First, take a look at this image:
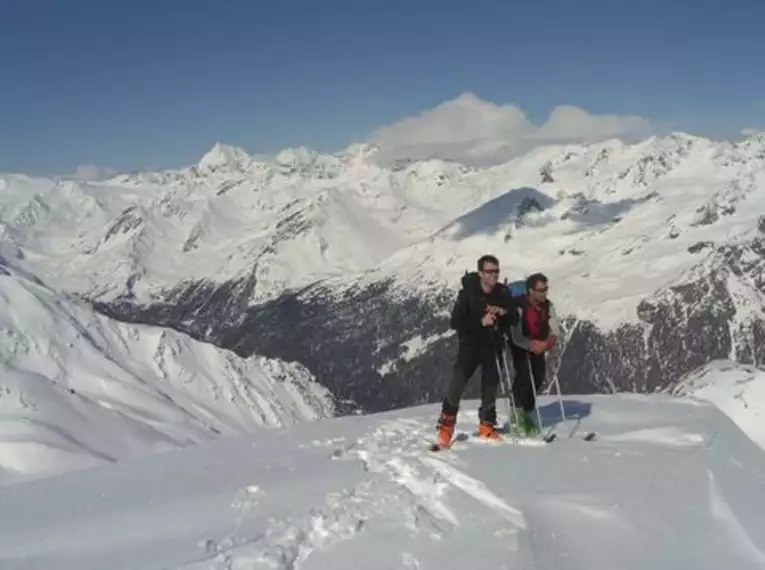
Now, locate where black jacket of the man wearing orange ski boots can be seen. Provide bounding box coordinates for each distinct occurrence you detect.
[449,272,518,349]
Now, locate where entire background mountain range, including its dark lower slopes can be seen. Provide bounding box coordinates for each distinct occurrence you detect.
[0,130,765,411]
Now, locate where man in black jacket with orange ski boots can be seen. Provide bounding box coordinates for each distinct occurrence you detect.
[438,254,517,447]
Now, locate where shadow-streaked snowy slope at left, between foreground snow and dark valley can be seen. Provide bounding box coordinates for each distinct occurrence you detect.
[0,257,334,484]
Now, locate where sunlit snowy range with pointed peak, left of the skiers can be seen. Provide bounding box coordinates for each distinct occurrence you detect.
[0,144,488,303]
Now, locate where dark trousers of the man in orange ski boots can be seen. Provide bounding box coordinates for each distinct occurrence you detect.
[442,344,499,425]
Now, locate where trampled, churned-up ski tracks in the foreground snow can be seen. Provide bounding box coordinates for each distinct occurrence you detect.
[184,412,526,570]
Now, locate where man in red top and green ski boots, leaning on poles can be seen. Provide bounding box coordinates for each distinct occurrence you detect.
[510,273,560,435]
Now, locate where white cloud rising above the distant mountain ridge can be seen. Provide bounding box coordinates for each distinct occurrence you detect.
[369,93,655,166]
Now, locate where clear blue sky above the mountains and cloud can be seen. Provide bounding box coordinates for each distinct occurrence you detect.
[0,0,765,174]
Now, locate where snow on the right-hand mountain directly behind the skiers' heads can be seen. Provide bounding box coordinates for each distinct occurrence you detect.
[374,135,765,331]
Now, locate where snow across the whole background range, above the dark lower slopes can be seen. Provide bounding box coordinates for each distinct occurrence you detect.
[0,133,765,324]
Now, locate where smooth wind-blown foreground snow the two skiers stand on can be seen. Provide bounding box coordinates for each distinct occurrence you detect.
[0,395,765,570]
